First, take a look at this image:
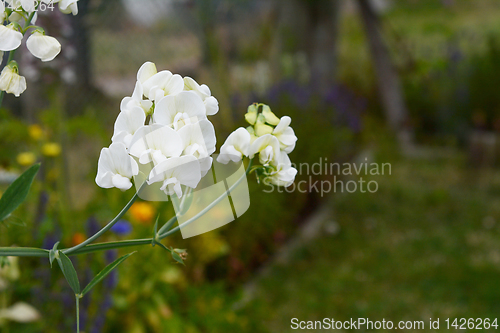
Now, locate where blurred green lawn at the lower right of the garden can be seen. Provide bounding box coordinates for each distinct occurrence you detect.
[237,152,500,332]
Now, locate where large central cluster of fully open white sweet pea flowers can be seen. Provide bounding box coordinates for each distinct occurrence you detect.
[96,62,219,197]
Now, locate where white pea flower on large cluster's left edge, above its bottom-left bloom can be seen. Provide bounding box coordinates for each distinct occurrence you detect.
[111,106,146,149]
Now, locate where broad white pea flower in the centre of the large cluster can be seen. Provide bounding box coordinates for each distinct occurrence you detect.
[129,124,183,165]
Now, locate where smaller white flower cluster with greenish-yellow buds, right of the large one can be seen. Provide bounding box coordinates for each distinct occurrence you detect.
[217,104,297,186]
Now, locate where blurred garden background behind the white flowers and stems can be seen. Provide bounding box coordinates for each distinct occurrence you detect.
[0,0,500,333]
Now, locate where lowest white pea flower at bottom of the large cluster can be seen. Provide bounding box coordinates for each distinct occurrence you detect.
[148,155,201,198]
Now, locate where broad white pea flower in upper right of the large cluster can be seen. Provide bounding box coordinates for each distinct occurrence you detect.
[153,91,205,130]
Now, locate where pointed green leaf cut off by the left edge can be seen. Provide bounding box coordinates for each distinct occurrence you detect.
[0,164,40,221]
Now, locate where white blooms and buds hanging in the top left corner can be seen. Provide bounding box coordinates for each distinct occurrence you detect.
[0,0,78,97]
